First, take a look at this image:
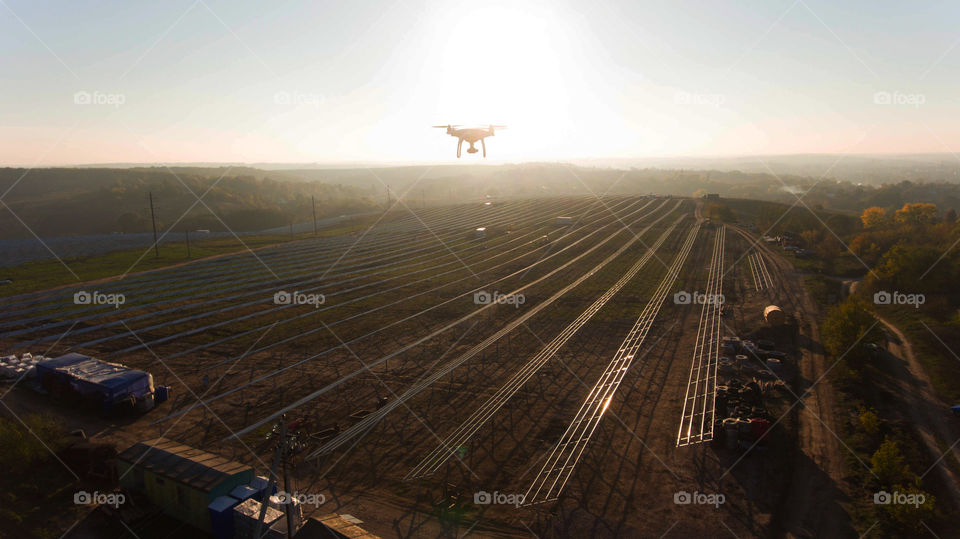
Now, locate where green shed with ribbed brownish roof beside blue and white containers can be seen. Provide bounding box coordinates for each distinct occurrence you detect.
[117,438,253,532]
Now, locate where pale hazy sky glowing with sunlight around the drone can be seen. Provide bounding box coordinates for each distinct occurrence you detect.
[0,0,960,165]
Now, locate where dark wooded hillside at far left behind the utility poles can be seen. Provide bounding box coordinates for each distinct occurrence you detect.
[0,168,376,239]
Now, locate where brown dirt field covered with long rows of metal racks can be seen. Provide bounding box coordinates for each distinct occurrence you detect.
[0,198,850,537]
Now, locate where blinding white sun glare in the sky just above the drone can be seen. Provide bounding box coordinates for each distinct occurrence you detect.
[433,5,576,151]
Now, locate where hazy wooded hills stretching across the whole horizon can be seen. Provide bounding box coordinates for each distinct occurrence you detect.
[0,160,960,239]
